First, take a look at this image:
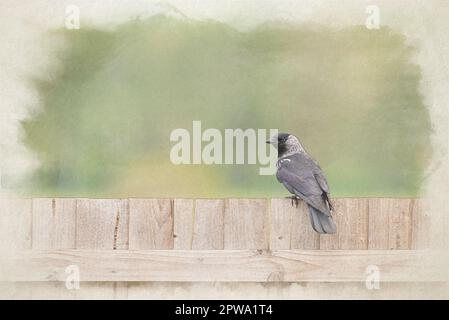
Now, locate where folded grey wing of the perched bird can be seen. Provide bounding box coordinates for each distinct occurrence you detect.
[276,153,330,215]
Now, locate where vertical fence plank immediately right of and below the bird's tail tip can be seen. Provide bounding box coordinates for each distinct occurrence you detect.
[320,198,368,250]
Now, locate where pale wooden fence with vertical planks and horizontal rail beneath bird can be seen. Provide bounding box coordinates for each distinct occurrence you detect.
[0,198,447,282]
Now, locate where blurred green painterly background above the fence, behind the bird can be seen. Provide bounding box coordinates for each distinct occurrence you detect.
[21,16,431,197]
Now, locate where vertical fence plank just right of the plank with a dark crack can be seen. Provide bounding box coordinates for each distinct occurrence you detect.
[129,199,173,250]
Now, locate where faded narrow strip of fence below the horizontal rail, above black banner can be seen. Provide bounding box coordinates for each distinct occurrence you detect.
[4,281,449,300]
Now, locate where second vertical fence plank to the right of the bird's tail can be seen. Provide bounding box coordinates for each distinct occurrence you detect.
[368,198,412,249]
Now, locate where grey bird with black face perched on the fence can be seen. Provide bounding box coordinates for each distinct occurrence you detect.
[266,133,337,234]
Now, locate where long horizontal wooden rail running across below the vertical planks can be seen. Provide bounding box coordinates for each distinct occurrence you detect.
[0,250,448,282]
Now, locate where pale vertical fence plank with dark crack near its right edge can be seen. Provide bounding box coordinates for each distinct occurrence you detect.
[76,199,128,250]
